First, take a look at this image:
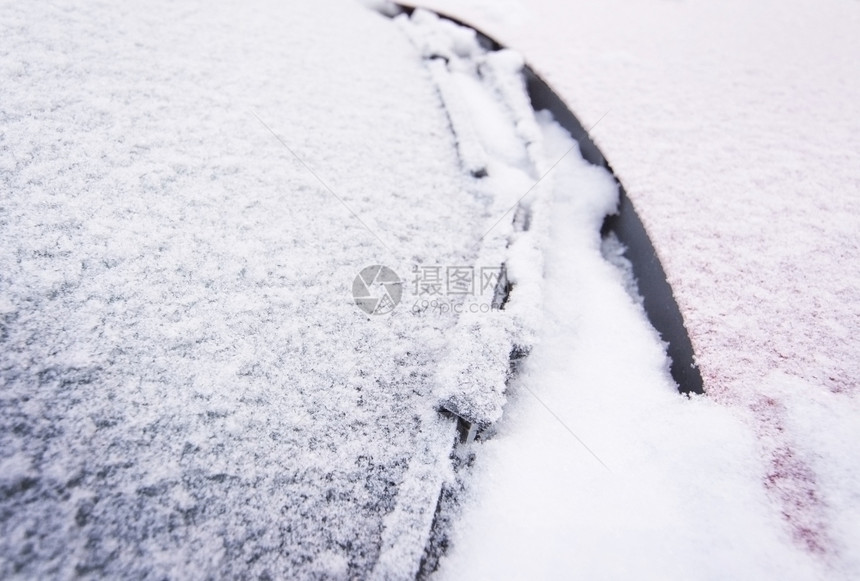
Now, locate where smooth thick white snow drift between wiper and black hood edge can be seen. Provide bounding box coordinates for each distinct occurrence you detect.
[438,107,822,579]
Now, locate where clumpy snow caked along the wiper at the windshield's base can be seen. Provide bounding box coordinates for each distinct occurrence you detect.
[377,10,617,577]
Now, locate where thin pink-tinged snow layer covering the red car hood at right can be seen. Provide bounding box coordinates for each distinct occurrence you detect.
[418,0,860,578]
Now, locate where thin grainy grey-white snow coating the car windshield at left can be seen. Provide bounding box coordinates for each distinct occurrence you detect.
[0,1,485,578]
